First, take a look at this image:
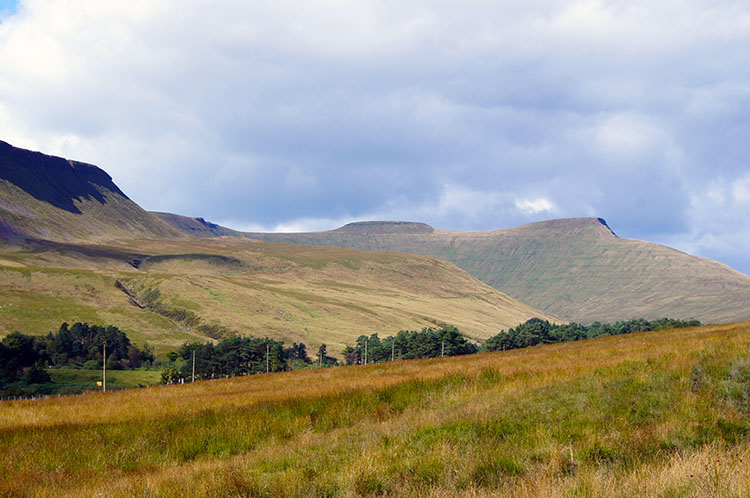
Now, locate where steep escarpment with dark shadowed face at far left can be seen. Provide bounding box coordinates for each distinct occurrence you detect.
[0,141,185,244]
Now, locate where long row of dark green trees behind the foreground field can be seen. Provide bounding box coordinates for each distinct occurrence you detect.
[0,318,700,393]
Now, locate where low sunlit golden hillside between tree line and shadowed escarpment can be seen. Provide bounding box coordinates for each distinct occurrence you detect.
[0,237,548,355]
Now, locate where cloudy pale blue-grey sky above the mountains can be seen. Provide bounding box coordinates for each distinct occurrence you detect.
[0,0,750,274]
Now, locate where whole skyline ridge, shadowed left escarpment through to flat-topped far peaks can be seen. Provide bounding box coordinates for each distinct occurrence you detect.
[0,142,750,323]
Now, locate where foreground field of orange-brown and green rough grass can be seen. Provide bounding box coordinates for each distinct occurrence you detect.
[0,323,750,497]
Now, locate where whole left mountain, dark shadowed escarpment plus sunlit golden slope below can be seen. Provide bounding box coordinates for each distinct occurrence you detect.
[0,142,547,355]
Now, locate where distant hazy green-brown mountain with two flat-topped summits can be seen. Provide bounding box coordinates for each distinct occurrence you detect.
[238,218,750,322]
